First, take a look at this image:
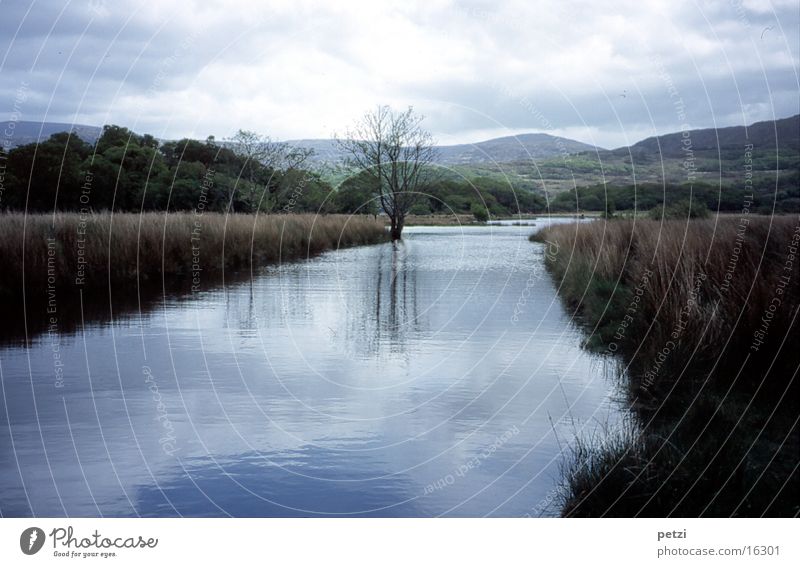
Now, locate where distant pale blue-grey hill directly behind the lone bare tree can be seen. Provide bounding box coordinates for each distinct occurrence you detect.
[289,134,602,165]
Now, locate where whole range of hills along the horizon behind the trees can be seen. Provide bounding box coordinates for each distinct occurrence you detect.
[0,115,800,199]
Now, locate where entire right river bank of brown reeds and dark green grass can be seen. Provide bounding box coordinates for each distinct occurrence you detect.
[533,216,800,517]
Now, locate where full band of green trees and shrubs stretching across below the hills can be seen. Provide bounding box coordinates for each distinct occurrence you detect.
[9,115,780,223]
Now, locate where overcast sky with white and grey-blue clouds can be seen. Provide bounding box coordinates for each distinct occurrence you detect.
[0,0,800,147]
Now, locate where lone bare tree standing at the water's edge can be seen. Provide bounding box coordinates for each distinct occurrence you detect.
[336,106,436,240]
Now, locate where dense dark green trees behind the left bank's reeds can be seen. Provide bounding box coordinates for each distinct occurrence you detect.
[0,125,333,212]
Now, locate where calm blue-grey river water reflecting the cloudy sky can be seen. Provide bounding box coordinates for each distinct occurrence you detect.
[0,222,618,516]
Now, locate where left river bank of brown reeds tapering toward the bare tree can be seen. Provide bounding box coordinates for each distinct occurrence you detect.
[0,213,385,300]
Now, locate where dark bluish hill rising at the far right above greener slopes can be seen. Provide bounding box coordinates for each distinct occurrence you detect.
[612,114,800,158]
